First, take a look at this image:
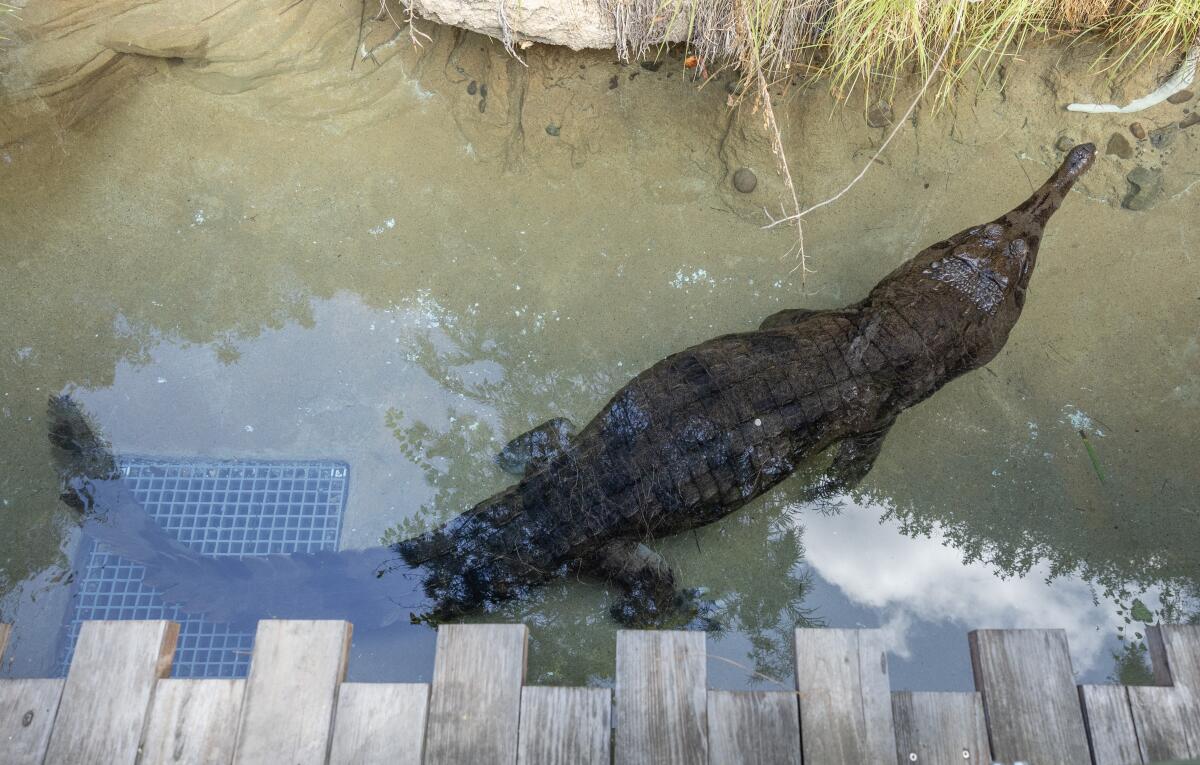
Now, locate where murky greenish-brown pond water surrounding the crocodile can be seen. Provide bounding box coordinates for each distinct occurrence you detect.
[0,19,1200,688]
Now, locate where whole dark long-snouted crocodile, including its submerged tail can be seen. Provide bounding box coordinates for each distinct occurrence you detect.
[50,144,1096,625]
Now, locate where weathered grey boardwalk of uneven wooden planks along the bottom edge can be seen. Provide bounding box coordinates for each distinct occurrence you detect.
[0,621,1200,765]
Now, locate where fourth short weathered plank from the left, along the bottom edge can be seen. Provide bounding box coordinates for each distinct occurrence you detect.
[517,686,612,765]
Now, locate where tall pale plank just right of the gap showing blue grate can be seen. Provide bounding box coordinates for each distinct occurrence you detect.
[233,620,352,765]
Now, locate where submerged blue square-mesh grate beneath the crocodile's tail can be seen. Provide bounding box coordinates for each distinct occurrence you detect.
[60,457,350,677]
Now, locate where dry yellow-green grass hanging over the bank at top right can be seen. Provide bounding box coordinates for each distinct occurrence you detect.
[600,0,1200,97]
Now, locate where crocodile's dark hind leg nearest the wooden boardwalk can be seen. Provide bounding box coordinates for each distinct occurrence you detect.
[584,540,715,628]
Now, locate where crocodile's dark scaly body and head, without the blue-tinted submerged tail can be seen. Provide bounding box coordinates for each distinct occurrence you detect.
[396,144,1096,620]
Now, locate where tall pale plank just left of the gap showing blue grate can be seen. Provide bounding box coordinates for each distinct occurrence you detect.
[46,621,179,765]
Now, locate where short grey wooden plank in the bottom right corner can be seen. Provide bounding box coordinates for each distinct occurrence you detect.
[1128,686,1200,763]
